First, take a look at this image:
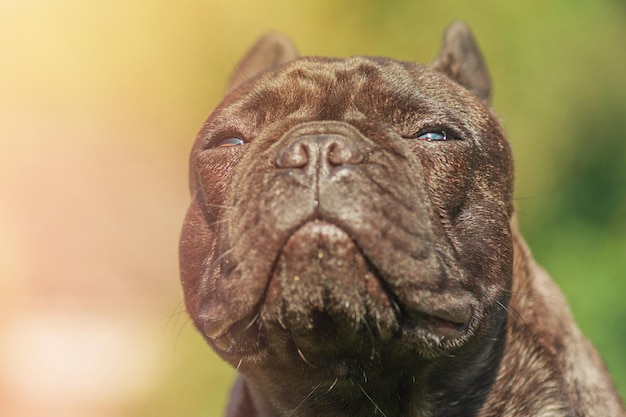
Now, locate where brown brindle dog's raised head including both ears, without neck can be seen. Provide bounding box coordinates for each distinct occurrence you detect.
[180,24,513,412]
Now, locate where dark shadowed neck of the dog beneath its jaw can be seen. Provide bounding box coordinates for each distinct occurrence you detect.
[227,300,507,417]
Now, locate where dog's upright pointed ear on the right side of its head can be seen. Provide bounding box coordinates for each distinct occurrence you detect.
[432,22,491,104]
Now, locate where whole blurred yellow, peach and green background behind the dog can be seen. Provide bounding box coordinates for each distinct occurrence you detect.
[0,0,626,417]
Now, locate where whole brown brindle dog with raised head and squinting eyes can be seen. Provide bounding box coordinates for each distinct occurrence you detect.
[180,22,626,417]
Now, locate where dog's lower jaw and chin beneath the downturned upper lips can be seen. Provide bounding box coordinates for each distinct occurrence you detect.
[207,220,473,357]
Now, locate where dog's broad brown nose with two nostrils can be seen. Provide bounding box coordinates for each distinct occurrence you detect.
[276,134,365,171]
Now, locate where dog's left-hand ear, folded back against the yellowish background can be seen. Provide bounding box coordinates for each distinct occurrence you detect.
[226,33,298,94]
